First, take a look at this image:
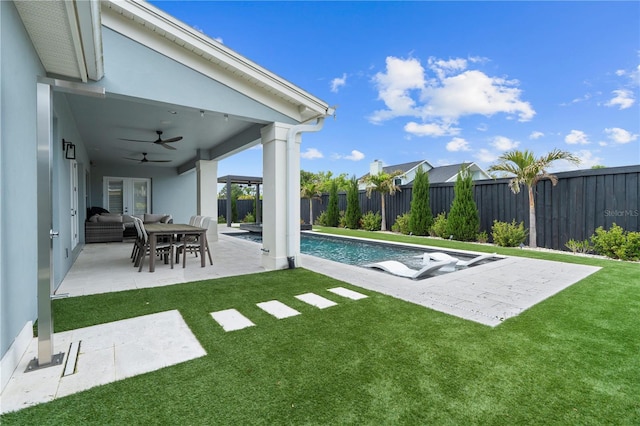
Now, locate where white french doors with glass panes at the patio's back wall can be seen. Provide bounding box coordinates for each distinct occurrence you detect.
[102,176,151,214]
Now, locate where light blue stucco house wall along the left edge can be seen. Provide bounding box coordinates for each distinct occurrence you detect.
[0,1,44,384]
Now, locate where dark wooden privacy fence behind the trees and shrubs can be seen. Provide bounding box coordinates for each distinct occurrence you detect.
[218,166,640,250]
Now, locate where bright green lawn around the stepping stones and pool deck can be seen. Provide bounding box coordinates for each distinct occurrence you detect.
[0,230,640,425]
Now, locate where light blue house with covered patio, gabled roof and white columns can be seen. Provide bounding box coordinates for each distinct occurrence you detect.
[0,0,334,389]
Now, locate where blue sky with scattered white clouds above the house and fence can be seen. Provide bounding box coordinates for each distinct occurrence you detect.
[152,1,640,177]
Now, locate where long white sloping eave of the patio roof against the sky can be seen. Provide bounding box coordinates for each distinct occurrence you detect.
[102,0,332,122]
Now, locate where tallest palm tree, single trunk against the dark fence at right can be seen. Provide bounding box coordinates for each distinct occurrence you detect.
[488,148,580,247]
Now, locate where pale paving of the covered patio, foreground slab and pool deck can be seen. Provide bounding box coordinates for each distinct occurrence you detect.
[0,225,599,412]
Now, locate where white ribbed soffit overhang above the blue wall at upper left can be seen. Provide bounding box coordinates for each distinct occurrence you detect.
[14,0,87,82]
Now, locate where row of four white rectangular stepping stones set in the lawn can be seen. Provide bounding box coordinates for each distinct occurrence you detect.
[211,287,367,332]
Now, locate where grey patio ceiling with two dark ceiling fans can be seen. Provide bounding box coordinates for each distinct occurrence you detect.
[66,94,263,172]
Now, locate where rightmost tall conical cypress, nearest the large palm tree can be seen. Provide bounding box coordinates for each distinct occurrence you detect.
[447,166,480,241]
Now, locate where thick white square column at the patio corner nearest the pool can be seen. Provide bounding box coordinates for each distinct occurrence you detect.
[261,123,290,270]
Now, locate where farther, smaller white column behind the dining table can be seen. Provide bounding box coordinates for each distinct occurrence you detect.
[196,160,218,241]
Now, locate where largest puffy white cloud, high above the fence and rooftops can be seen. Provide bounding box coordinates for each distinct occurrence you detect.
[369,56,535,124]
